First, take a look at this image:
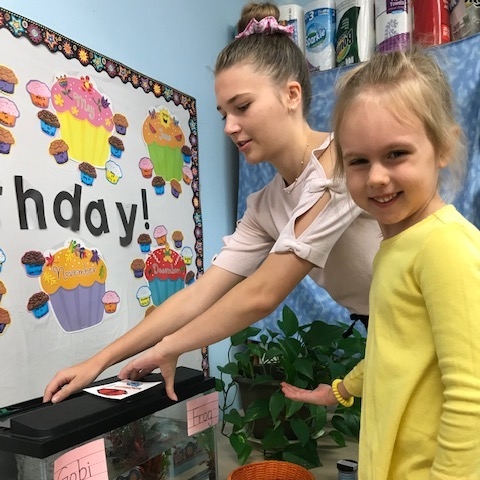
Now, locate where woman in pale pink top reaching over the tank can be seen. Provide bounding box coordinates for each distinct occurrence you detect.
[44,3,380,402]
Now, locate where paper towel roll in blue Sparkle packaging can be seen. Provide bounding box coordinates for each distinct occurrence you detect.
[304,0,336,71]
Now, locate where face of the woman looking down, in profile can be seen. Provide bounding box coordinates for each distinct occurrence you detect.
[215,64,289,164]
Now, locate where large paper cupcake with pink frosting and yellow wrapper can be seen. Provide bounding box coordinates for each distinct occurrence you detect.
[51,75,114,168]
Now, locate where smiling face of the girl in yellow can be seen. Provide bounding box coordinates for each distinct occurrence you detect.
[339,97,444,238]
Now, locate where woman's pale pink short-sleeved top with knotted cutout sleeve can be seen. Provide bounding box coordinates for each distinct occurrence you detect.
[213,134,381,315]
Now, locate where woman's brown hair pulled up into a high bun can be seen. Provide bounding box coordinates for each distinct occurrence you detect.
[215,2,312,118]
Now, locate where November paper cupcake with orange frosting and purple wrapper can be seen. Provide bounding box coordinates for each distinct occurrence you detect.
[40,240,107,332]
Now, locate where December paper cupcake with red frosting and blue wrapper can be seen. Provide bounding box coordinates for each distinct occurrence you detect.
[145,244,186,306]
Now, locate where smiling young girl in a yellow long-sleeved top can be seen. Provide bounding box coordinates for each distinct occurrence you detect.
[283,50,480,480]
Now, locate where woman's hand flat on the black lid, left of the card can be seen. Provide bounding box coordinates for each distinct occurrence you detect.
[43,359,102,403]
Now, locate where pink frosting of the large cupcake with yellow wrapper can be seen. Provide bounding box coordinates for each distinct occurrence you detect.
[52,76,114,132]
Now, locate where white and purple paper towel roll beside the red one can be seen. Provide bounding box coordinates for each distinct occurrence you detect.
[375,0,412,52]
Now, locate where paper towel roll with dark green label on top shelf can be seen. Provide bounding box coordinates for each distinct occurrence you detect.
[335,0,375,67]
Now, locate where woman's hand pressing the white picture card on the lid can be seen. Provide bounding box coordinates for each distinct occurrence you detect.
[118,337,179,401]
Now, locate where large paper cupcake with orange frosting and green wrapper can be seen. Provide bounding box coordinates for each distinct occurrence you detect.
[142,108,185,182]
